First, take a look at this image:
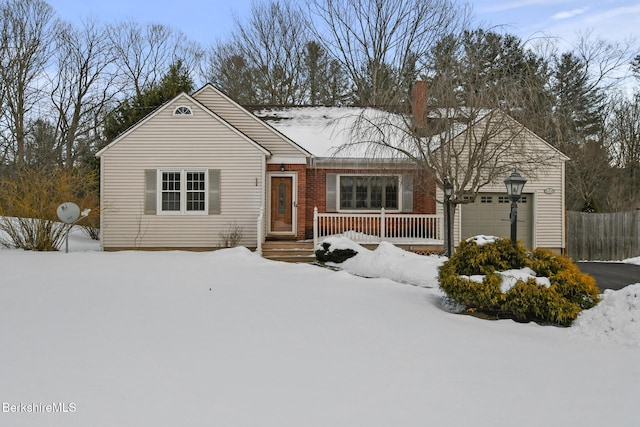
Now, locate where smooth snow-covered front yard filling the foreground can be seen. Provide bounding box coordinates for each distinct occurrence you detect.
[0,234,640,427]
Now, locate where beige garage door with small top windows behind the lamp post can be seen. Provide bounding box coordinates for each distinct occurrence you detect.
[461,193,533,249]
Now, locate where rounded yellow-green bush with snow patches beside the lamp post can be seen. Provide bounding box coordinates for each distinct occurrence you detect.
[439,238,599,326]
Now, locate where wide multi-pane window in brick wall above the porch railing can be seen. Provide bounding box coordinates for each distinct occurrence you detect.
[339,175,400,210]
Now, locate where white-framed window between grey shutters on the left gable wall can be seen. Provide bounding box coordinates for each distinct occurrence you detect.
[159,170,207,214]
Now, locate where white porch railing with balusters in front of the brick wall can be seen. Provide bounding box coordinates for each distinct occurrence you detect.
[313,208,443,247]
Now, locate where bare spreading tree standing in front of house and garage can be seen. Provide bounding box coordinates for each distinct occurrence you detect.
[332,22,561,251]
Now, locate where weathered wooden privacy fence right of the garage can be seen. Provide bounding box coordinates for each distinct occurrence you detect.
[567,210,640,261]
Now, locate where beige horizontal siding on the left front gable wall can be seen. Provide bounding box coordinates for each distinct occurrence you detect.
[101,99,265,249]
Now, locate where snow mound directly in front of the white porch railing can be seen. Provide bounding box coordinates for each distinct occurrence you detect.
[324,237,446,288]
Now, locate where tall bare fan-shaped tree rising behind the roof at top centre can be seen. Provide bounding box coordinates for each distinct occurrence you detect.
[310,0,469,106]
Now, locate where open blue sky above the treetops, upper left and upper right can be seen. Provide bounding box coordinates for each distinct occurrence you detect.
[48,0,640,46]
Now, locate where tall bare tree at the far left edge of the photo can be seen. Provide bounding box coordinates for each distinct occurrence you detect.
[0,0,55,166]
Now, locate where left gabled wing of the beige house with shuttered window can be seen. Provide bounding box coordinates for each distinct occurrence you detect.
[97,85,310,250]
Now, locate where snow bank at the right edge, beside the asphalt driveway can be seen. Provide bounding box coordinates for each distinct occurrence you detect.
[571,283,640,347]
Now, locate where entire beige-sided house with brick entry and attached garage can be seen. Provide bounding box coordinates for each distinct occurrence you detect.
[97,84,567,254]
